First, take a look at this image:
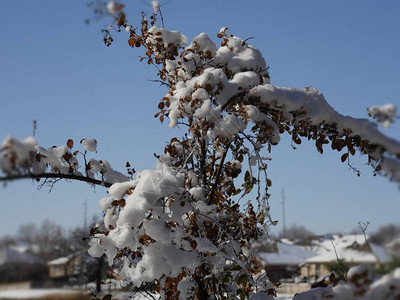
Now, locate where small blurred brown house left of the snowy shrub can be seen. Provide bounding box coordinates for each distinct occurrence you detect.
[47,256,81,281]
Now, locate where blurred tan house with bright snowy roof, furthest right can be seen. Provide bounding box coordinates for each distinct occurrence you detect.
[300,234,392,279]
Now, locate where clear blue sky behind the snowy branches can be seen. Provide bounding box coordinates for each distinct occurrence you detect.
[0,0,400,236]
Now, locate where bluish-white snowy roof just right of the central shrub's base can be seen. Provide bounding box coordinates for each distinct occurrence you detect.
[257,242,317,265]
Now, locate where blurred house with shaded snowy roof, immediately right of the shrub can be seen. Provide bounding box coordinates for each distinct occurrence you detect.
[253,240,317,282]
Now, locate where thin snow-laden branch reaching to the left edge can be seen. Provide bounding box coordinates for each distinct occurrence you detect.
[0,136,128,187]
